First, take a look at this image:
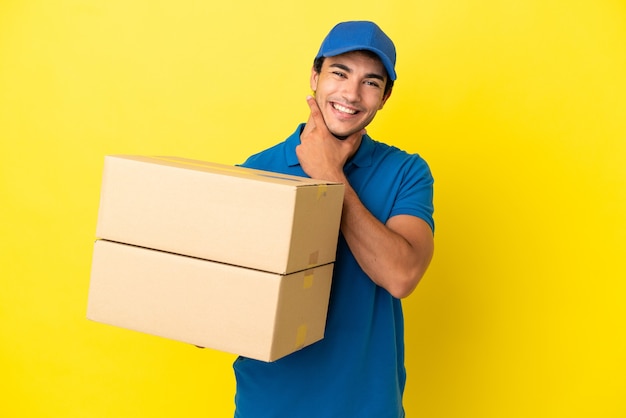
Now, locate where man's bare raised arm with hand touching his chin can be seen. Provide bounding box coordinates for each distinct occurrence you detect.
[296,98,434,298]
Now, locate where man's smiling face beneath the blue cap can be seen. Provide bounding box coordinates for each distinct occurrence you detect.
[311,51,389,138]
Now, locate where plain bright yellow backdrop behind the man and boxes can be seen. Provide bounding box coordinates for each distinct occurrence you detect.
[0,0,626,418]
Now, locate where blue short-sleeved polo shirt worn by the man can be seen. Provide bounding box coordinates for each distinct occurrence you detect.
[233,124,434,418]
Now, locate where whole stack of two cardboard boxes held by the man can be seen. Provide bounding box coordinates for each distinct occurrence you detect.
[87,155,344,361]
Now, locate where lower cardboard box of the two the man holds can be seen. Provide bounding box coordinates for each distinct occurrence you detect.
[87,240,333,361]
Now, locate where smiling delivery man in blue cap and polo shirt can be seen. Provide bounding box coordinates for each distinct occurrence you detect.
[234,21,434,418]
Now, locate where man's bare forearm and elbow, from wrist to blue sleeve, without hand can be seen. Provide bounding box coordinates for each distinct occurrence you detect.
[341,182,433,298]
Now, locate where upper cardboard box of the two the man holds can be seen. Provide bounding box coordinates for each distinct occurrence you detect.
[96,155,344,274]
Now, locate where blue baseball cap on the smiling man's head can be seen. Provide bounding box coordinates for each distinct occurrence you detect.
[315,20,396,80]
